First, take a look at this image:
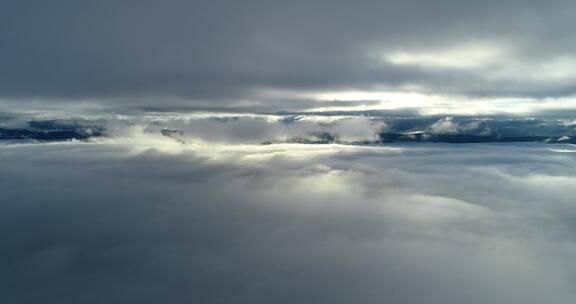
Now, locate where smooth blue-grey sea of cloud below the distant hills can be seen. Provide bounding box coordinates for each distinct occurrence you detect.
[0,143,576,304]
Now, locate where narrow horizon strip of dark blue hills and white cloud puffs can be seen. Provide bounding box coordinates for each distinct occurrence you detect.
[0,112,576,144]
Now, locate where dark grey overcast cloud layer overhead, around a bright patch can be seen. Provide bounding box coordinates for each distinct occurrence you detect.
[0,0,576,106]
